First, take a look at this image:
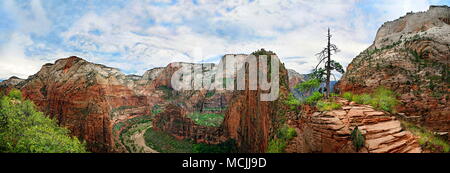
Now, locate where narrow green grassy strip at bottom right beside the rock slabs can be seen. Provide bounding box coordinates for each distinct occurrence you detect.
[401,121,450,153]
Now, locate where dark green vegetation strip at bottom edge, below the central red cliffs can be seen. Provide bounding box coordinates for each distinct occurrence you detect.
[192,139,237,153]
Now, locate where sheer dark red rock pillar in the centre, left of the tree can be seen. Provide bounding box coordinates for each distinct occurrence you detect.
[224,54,289,153]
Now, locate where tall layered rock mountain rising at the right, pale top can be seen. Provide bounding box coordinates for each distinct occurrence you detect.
[337,6,450,133]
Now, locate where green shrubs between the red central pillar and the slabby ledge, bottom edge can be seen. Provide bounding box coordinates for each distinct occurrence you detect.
[267,125,297,153]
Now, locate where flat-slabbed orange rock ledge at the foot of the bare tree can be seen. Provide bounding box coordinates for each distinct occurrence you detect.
[294,99,422,153]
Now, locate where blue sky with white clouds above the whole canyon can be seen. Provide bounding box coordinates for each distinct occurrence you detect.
[0,0,450,79]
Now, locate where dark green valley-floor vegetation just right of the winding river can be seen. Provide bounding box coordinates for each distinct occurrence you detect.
[144,128,193,153]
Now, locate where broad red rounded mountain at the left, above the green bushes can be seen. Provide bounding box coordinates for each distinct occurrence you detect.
[16,57,149,152]
